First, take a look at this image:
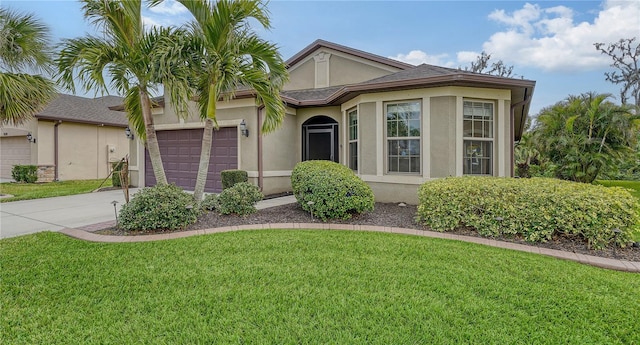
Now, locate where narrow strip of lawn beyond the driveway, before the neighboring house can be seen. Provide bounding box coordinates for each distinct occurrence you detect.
[0,179,111,202]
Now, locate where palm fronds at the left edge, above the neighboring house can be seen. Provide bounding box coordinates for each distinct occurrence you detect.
[0,8,56,125]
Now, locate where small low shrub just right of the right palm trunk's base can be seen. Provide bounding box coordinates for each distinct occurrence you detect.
[215,182,264,216]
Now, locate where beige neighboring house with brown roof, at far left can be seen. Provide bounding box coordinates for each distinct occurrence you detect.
[0,94,130,182]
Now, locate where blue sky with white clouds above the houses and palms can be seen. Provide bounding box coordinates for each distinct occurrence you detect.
[5,0,640,115]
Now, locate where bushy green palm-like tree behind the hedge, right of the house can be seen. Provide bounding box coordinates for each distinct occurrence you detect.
[533,92,640,183]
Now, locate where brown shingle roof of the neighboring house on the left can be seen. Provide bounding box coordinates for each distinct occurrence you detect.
[36,93,128,127]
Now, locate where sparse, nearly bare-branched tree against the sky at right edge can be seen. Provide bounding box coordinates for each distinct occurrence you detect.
[593,37,640,106]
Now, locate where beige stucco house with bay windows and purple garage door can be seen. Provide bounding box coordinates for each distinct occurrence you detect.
[130,40,535,203]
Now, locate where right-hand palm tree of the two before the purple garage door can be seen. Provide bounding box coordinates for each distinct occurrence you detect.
[170,0,288,202]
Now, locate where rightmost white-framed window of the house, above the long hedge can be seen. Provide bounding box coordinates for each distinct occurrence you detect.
[462,101,495,175]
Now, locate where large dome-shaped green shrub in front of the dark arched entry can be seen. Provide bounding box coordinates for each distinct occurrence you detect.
[291,161,375,220]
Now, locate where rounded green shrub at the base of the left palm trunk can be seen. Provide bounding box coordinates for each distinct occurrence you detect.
[118,184,198,231]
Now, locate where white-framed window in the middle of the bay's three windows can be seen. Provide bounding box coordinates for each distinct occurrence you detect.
[385,101,422,174]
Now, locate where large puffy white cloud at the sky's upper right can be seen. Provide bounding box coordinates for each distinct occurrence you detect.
[483,1,640,71]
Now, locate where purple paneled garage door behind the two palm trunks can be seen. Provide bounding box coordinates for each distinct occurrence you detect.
[145,127,238,193]
